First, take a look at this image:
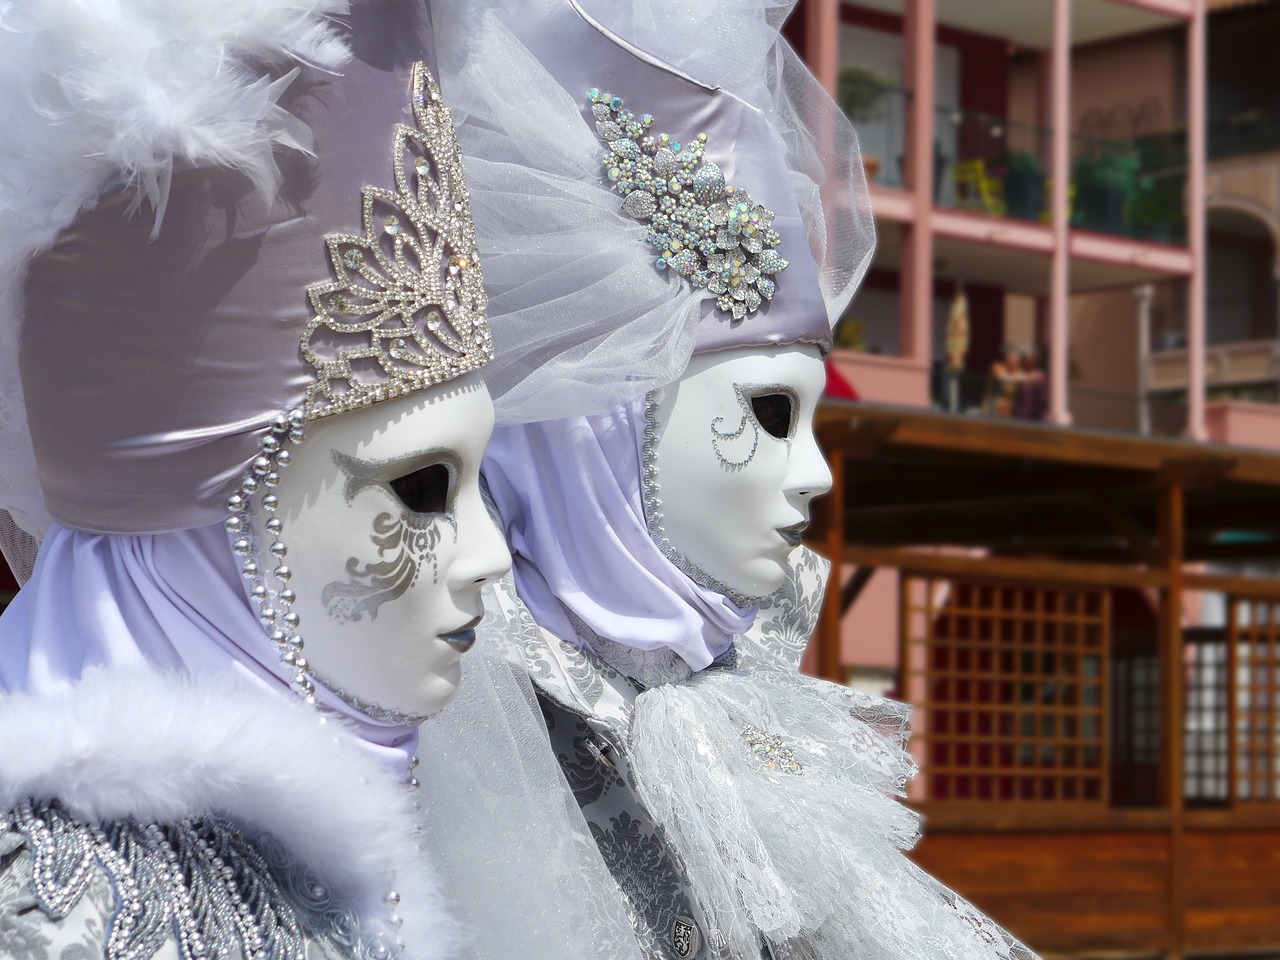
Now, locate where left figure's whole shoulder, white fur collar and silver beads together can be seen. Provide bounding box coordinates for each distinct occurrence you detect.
[0,669,453,960]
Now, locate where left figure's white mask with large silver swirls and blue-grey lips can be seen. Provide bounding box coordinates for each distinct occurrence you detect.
[264,374,511,718]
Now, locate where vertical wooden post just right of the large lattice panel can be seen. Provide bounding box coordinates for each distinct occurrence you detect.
[1160,484,1187,960]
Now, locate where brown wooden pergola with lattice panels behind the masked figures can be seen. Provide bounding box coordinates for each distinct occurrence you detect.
[810,402,1280,957]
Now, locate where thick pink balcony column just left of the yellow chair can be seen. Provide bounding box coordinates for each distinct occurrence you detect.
[899,0,937,366]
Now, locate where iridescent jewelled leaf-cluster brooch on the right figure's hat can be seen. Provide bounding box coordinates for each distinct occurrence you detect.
[588,88,787,320]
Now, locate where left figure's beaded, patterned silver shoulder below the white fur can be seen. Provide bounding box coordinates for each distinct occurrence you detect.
[0,800,353,960]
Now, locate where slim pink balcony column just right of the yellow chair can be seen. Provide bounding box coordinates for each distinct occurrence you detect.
[1048,0,1071,425]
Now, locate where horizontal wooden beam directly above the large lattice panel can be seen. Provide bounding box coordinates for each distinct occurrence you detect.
[844,544,1169,589]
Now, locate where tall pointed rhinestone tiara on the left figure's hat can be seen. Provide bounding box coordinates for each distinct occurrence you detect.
[302,63,493,420]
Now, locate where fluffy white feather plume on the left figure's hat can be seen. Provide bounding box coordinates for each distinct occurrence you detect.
[0,0,348,568]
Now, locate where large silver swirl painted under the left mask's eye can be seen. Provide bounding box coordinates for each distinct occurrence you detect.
[320,512,458,623]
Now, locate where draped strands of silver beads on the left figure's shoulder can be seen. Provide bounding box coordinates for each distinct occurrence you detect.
[0,800,399,960]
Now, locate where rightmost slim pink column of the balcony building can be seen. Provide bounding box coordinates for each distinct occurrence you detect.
[1187,0,1208,440]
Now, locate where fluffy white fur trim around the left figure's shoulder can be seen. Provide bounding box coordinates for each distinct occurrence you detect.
[0,669,456,960]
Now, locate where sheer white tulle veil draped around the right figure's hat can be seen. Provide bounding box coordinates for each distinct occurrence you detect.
[433,0,874,424]
